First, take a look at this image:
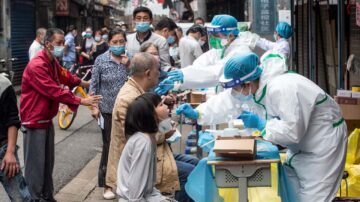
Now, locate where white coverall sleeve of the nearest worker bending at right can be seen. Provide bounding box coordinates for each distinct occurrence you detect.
[263,83,312,146]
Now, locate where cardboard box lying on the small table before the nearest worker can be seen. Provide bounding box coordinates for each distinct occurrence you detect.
[214,136,256,160]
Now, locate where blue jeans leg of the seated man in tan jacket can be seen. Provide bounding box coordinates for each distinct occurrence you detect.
[174,154,199,202]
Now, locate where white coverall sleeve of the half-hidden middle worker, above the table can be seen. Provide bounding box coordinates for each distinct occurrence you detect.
[196,89,241,125]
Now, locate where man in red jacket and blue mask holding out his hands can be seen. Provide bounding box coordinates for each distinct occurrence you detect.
[20,28,101,201]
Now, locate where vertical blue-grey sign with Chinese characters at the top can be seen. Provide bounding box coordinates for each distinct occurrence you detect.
[252,0,277,34]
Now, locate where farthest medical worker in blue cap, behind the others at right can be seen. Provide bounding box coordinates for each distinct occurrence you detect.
[256,22,293,58]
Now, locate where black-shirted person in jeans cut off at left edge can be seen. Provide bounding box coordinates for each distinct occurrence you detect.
[0,74,31,201]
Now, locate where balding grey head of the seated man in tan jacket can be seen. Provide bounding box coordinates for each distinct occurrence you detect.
[130,52,158,76]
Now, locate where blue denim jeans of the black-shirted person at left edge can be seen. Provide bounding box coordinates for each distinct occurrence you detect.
[0,144,31,201]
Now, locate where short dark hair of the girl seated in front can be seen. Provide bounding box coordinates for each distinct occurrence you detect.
[125,93,161,138]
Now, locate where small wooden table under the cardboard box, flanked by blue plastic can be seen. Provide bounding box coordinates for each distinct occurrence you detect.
[207,159,280,202]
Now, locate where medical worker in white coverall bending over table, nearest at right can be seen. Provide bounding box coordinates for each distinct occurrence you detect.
[224,52,347,202]
